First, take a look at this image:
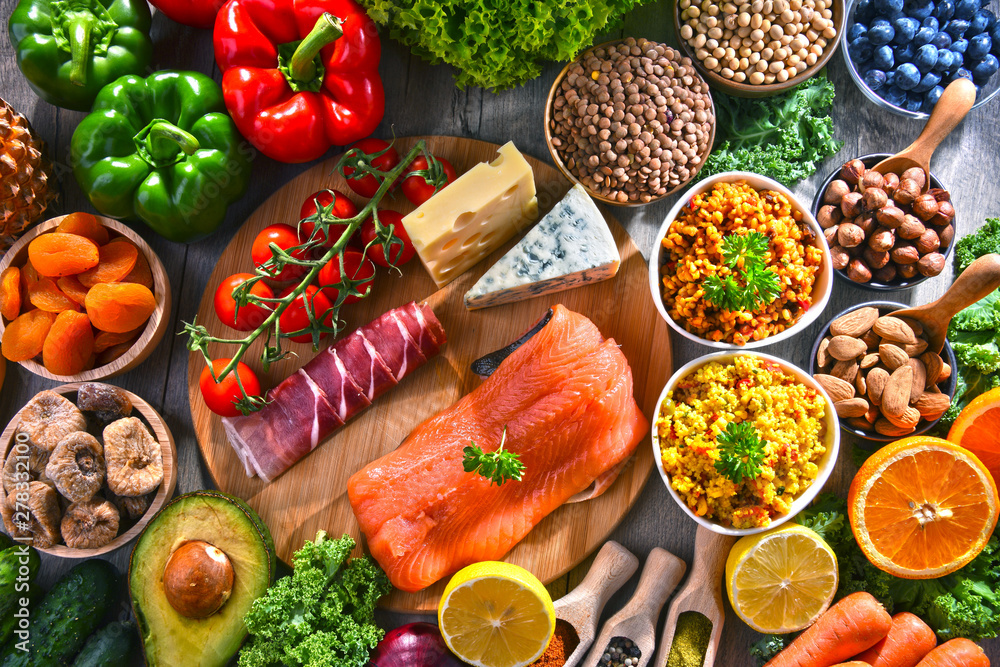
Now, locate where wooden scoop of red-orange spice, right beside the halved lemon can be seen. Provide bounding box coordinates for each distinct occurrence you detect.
[555,541,639,667]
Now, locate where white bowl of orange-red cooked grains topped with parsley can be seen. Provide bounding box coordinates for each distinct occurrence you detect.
[649,172,833,349]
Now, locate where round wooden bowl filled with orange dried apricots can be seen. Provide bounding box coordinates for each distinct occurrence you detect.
[0,213,170,382]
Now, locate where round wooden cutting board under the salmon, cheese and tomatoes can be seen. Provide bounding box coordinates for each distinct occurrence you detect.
[188,137,671,612]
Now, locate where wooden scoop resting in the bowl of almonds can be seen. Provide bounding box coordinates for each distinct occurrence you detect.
[890,253,1000,354]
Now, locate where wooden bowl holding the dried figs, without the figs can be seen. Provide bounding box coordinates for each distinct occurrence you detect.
[0,382,177,558]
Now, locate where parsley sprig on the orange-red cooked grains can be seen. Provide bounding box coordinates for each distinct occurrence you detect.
[703,232,781,311]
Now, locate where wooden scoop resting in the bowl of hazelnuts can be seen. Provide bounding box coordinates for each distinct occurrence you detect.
[872,77,976,185]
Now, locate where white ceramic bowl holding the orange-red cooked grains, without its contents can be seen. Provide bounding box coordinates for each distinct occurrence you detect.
[649,171,833,350]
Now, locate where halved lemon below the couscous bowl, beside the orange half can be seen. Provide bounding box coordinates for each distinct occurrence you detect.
[726,524,837,634]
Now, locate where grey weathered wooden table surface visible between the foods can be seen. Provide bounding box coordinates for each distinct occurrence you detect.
[0,0,1000,667]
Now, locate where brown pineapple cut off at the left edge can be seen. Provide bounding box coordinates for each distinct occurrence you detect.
[0,98,55,257]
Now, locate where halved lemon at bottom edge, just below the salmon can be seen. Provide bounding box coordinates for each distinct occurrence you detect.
[438,562,556,667]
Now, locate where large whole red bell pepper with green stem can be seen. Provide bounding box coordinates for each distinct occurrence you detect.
[213,0,385,162]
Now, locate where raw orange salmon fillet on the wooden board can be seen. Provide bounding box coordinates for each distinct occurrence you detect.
[348,306,649,591]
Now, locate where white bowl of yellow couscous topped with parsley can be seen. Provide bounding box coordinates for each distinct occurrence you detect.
[652,352,840,536]
